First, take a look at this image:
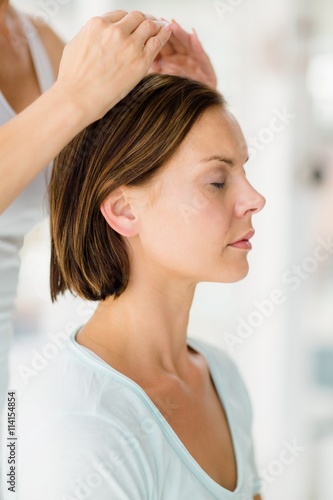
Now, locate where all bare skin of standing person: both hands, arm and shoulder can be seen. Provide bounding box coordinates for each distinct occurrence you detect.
[0,4,216,214]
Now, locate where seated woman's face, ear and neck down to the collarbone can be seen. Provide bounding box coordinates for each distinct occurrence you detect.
[77,109,264,379]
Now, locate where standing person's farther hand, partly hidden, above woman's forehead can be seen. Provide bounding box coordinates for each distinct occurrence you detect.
[150,21,217,88]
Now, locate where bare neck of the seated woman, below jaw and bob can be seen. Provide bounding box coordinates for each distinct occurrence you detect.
[83,281,195,374]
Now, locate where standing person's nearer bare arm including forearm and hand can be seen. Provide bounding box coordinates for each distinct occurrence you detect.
[0,11,171,214]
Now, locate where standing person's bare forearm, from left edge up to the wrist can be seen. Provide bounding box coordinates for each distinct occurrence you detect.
[0,87,88,214]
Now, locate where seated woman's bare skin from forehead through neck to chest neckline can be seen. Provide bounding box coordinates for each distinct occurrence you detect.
[76,108,265,500]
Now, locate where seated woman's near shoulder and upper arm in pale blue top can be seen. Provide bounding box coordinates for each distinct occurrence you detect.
[19,349,157,500]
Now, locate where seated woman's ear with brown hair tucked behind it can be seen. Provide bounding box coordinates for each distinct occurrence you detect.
[100,187,138,237]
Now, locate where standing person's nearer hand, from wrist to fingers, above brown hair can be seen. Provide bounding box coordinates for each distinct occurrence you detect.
[54,11,172,124]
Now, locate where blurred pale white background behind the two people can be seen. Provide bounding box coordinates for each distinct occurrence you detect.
[2,0,333,500]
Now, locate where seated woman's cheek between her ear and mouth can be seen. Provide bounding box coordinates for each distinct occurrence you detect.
[140,182,232,267]
